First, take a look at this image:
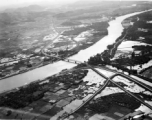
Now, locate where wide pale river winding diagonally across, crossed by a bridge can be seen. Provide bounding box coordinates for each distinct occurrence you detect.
[0,11,150,92]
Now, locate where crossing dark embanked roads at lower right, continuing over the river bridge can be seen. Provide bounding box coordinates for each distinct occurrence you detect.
[42,22,152,118]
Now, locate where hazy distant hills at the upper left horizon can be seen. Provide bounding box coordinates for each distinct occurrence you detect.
[0,5,52,27]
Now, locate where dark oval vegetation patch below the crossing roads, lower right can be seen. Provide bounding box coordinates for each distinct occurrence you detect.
[85,93,141,113]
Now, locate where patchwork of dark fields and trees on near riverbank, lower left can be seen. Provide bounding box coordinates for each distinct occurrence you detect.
[0,70,87,120]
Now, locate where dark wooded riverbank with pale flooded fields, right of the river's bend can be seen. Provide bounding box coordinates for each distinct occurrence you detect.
[89,9,151,74]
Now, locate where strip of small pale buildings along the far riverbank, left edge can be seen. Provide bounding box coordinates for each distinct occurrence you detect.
[0,54,45,78]
